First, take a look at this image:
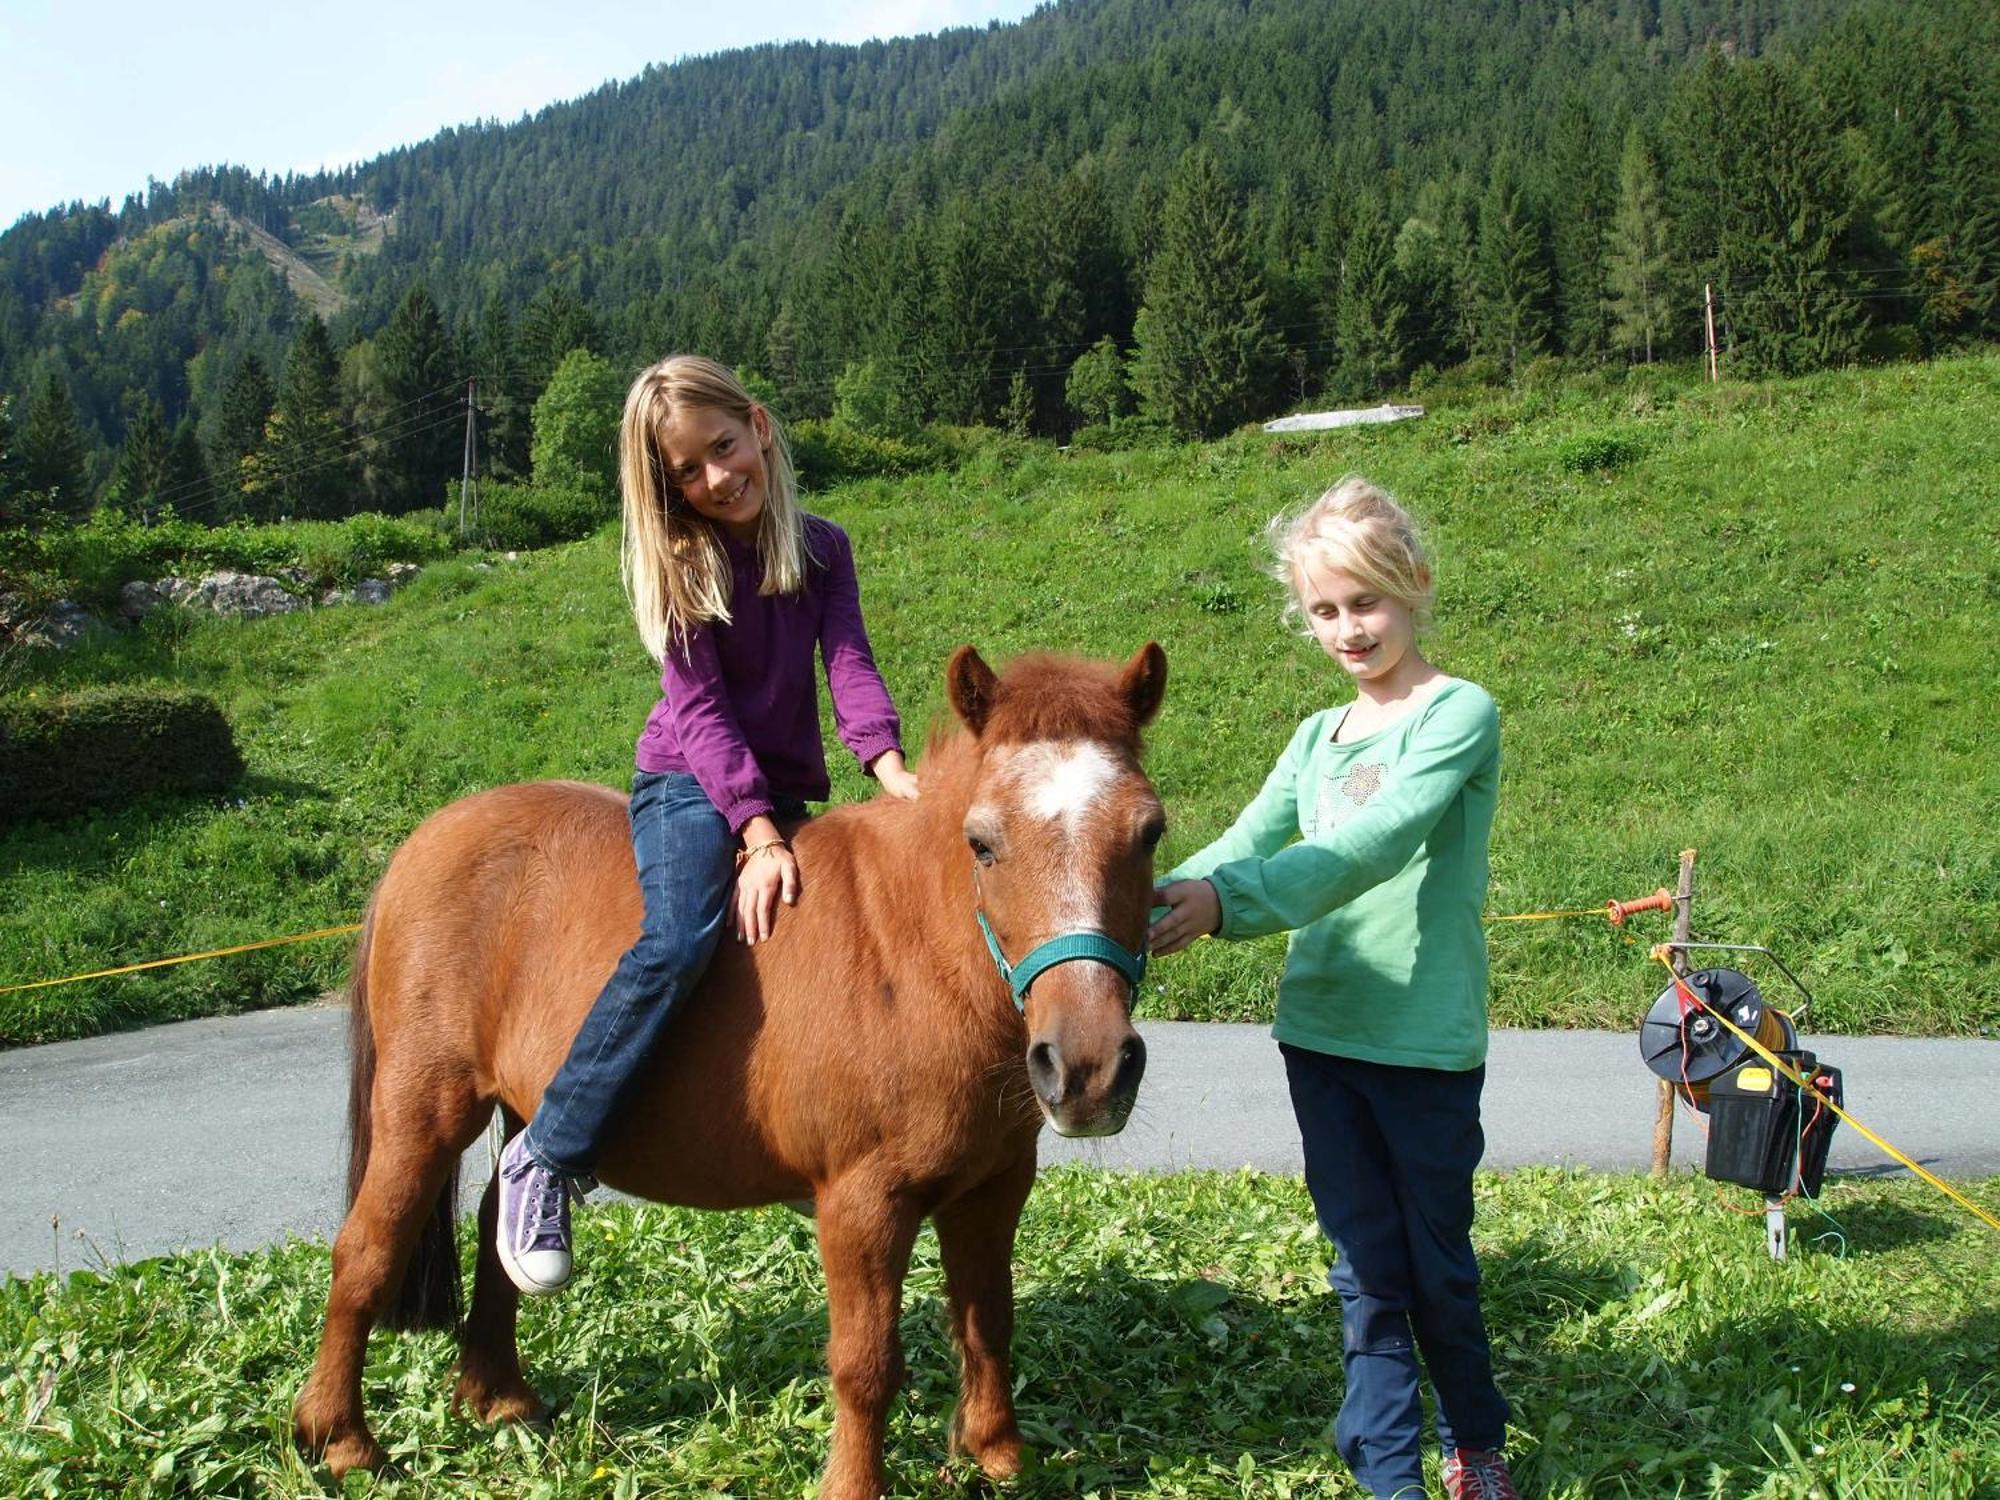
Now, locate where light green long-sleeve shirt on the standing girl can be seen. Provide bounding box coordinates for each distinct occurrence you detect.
[1168,678,1500,1072]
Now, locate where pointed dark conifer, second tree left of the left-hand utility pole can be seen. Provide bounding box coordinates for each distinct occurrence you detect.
[242,314,356,520]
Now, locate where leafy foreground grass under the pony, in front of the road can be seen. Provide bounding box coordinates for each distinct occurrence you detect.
[0,1168,2000,1500]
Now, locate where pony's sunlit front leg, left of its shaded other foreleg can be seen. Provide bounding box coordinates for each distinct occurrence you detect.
[818,1170,922,1500]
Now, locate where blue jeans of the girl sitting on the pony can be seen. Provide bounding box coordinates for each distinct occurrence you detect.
[526,770,806,1184]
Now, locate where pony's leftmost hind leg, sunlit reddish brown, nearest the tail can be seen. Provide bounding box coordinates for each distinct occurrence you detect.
[292,1074,492,1478]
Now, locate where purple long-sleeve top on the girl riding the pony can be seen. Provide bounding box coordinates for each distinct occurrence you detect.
[638,516,902,832]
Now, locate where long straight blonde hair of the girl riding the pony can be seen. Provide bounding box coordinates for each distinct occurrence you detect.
[618,354,814,662]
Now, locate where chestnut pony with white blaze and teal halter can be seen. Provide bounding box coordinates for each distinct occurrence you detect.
[292,644,1166,1500]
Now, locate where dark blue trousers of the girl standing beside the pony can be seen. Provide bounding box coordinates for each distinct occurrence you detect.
[1280,1044,1508,1496]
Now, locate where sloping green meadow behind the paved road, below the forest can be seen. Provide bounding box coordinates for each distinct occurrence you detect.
[0,354,2000,1044]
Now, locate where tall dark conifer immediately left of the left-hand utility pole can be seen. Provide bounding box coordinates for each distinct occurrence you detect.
[376,282,464,512]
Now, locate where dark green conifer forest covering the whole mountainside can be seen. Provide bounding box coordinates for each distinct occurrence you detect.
[0,0,2000,528]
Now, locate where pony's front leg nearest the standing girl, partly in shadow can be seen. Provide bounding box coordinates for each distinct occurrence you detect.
[932,1148,1034,1480]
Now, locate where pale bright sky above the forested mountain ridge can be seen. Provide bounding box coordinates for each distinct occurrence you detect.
[0,0,1036,228]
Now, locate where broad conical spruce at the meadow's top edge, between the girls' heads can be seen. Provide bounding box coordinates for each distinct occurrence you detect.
[1132,148,1284,438]
